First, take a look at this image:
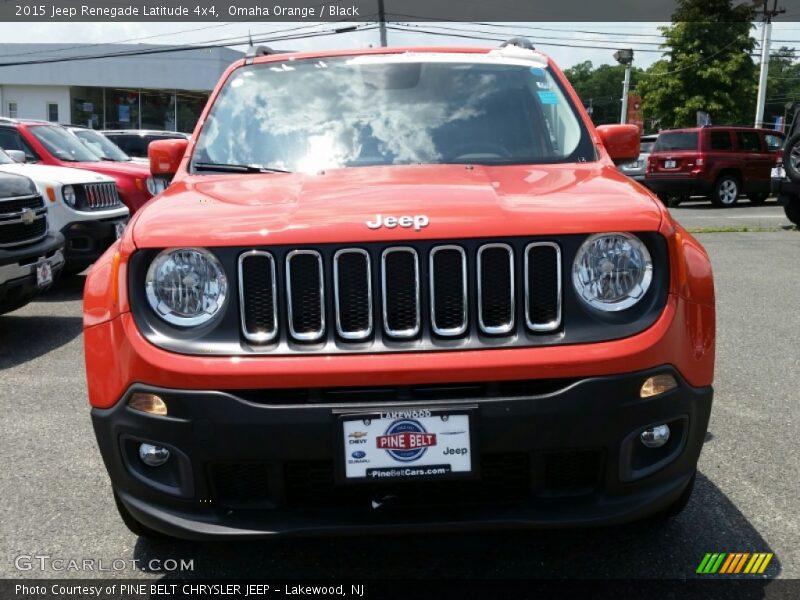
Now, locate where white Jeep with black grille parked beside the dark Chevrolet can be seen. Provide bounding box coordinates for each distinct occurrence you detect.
[0,149,128,273]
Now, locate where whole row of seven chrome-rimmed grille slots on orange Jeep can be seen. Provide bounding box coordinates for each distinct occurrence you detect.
[238,242,561,348]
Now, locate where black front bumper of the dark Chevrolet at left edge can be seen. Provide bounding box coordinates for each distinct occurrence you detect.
[0,233,64,314]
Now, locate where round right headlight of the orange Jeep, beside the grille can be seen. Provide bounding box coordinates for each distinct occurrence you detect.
[572,233,653,312]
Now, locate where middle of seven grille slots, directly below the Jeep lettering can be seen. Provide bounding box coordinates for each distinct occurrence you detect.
[381,247,420,338]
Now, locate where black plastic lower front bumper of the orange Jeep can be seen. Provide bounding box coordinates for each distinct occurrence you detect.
[92,367,713,539]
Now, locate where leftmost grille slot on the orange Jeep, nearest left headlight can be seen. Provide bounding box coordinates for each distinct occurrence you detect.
[239,250,278,343]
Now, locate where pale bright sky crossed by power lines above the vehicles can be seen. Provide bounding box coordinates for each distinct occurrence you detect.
[0,22,800,68]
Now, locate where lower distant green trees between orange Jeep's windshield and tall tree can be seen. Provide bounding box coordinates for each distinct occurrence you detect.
[564,60,643,125]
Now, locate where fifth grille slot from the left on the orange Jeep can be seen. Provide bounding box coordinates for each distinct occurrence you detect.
[430,246,467,336]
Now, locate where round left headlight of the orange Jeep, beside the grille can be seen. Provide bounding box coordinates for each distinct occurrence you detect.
[145,248,228,327]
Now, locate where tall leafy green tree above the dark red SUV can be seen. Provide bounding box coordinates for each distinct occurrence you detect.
[636,0,757,128]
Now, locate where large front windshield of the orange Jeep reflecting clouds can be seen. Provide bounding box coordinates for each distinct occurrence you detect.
[193,55,595,172]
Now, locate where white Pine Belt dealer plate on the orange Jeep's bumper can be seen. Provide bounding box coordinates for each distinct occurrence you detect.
[341,409,473,481]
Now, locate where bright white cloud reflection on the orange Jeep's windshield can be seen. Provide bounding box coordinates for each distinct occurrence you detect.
[202,62,497,170]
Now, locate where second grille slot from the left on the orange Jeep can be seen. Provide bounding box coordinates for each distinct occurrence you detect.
[286,250,325,342]
